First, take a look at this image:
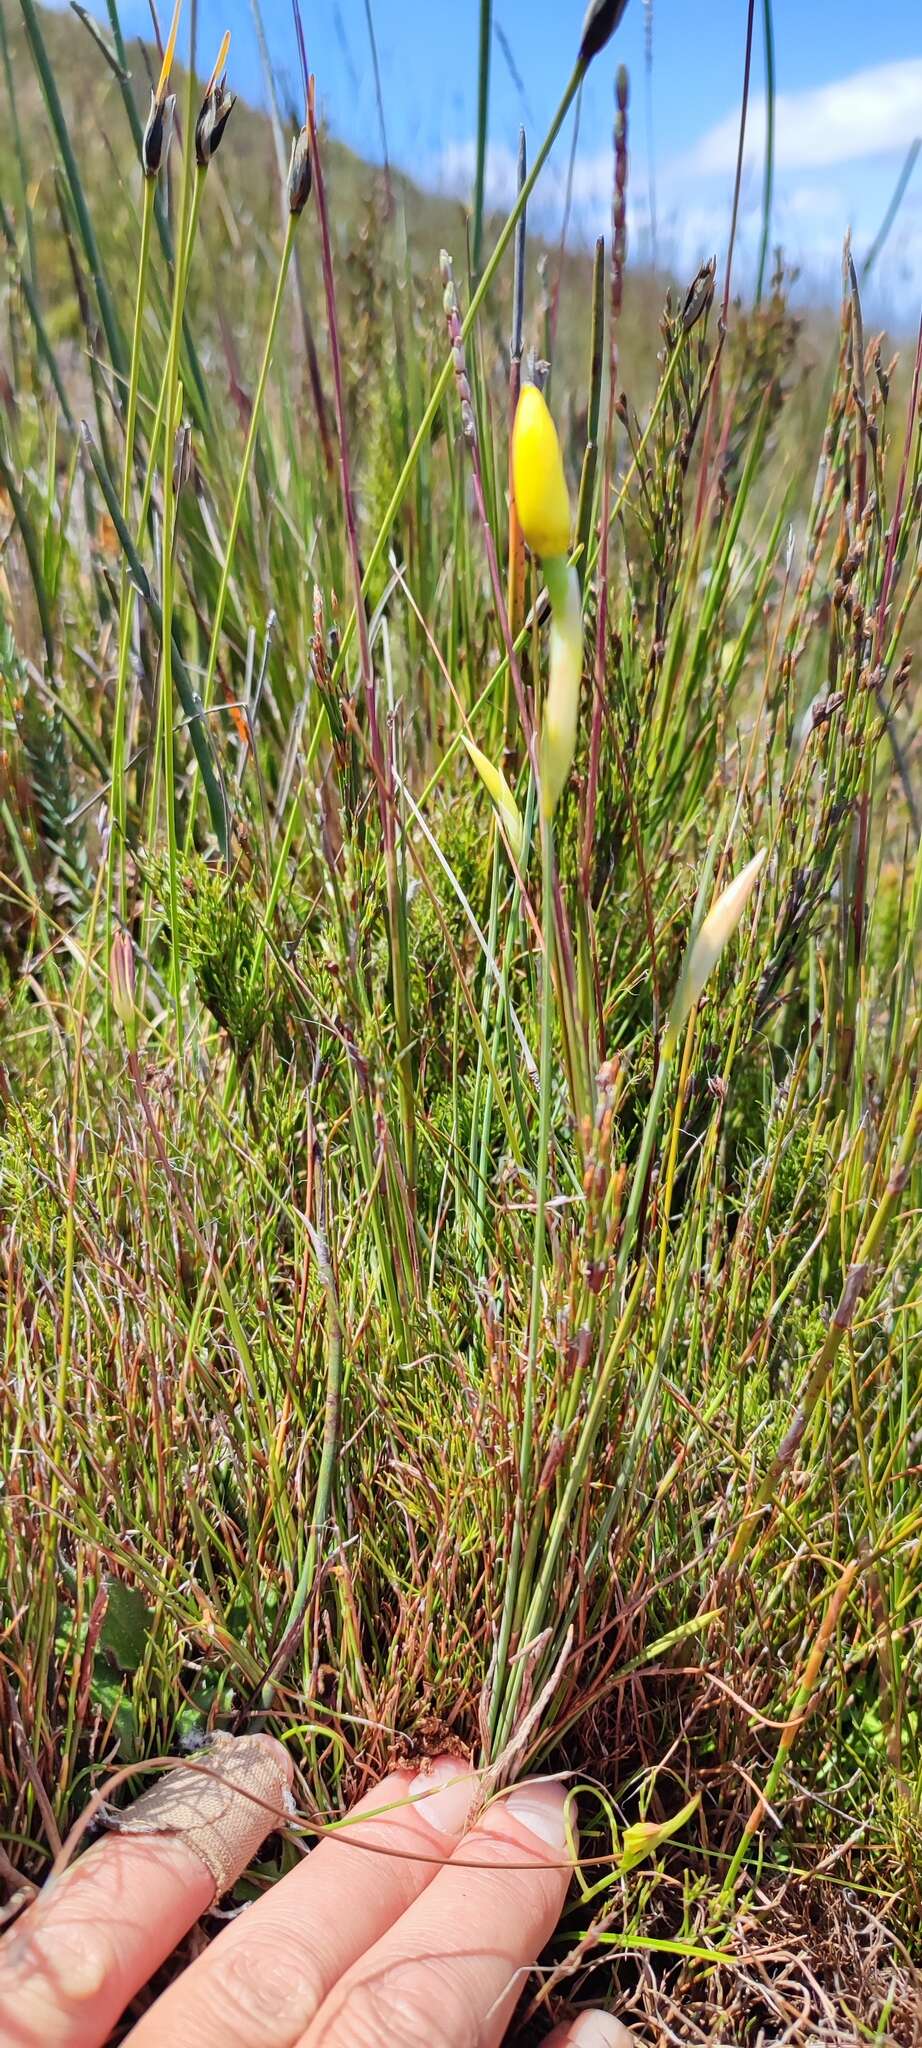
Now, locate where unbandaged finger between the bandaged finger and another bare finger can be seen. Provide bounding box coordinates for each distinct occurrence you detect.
[129,1757,477,2048]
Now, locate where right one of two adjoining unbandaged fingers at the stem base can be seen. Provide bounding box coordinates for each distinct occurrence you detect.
[297,1784,572,2048]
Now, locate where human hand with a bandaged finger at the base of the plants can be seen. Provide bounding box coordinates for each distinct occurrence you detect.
[0,1737,631,2048]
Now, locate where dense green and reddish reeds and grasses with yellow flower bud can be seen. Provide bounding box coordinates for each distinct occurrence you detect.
[0,0,922,2040]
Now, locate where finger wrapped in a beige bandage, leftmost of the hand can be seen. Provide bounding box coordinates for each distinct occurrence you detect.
[0,1735,291,2048]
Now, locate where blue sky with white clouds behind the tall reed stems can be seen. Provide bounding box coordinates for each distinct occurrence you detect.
[54,0,922,322]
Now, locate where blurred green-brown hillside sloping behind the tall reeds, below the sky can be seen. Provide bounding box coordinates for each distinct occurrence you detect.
[0,0,639,403]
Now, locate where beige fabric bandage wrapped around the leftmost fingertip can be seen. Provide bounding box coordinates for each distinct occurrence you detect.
[111,1735,291,1898]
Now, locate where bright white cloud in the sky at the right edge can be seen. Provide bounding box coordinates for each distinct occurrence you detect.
[686,57,922,174]
